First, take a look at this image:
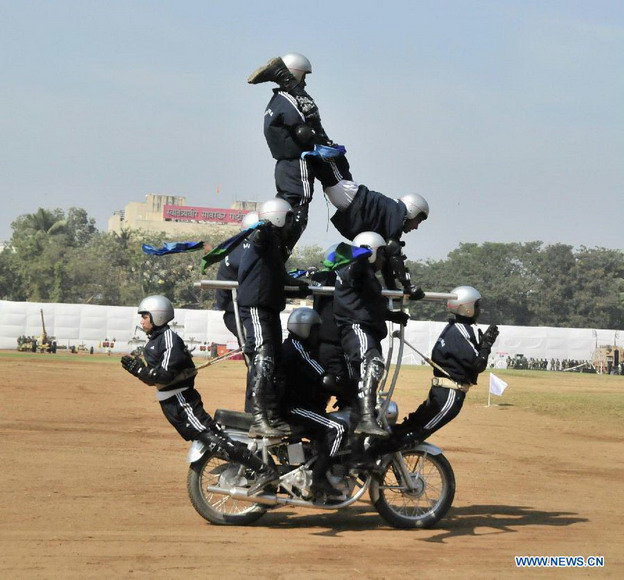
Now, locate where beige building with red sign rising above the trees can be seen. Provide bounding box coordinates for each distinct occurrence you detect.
[108,193,258,237]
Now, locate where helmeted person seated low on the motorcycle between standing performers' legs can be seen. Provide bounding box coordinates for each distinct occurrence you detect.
[281,307,346,497]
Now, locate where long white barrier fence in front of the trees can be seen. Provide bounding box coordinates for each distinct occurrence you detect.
[0,300,616,367]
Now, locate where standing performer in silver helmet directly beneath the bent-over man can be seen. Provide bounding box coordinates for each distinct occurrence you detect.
[334,232,409,437]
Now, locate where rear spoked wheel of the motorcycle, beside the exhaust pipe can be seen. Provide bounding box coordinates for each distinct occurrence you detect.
[186,453,266,526]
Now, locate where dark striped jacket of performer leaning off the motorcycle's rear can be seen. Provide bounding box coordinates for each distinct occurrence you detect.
[143,325,195,391]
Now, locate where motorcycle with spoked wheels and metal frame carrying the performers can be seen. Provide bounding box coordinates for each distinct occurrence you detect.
[187,280,455,529]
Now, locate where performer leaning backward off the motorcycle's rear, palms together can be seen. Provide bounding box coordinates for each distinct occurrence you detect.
[121,296,279,493]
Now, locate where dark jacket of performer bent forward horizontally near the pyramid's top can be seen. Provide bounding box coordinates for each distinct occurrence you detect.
[331,185,407,241]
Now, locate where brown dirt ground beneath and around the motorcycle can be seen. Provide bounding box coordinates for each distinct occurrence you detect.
[0,352,624,579]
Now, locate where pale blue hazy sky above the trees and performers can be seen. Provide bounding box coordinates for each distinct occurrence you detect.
[0,0,624,260]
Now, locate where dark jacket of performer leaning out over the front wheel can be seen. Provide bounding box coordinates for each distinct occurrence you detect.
[431,316,491,385]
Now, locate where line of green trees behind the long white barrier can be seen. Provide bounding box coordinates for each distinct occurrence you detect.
[0,208,624,328]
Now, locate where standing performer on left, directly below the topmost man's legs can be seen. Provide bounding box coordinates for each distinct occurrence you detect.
[238,198,307,437]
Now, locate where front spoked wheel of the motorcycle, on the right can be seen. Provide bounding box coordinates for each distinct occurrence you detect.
[370,450,455,528]
